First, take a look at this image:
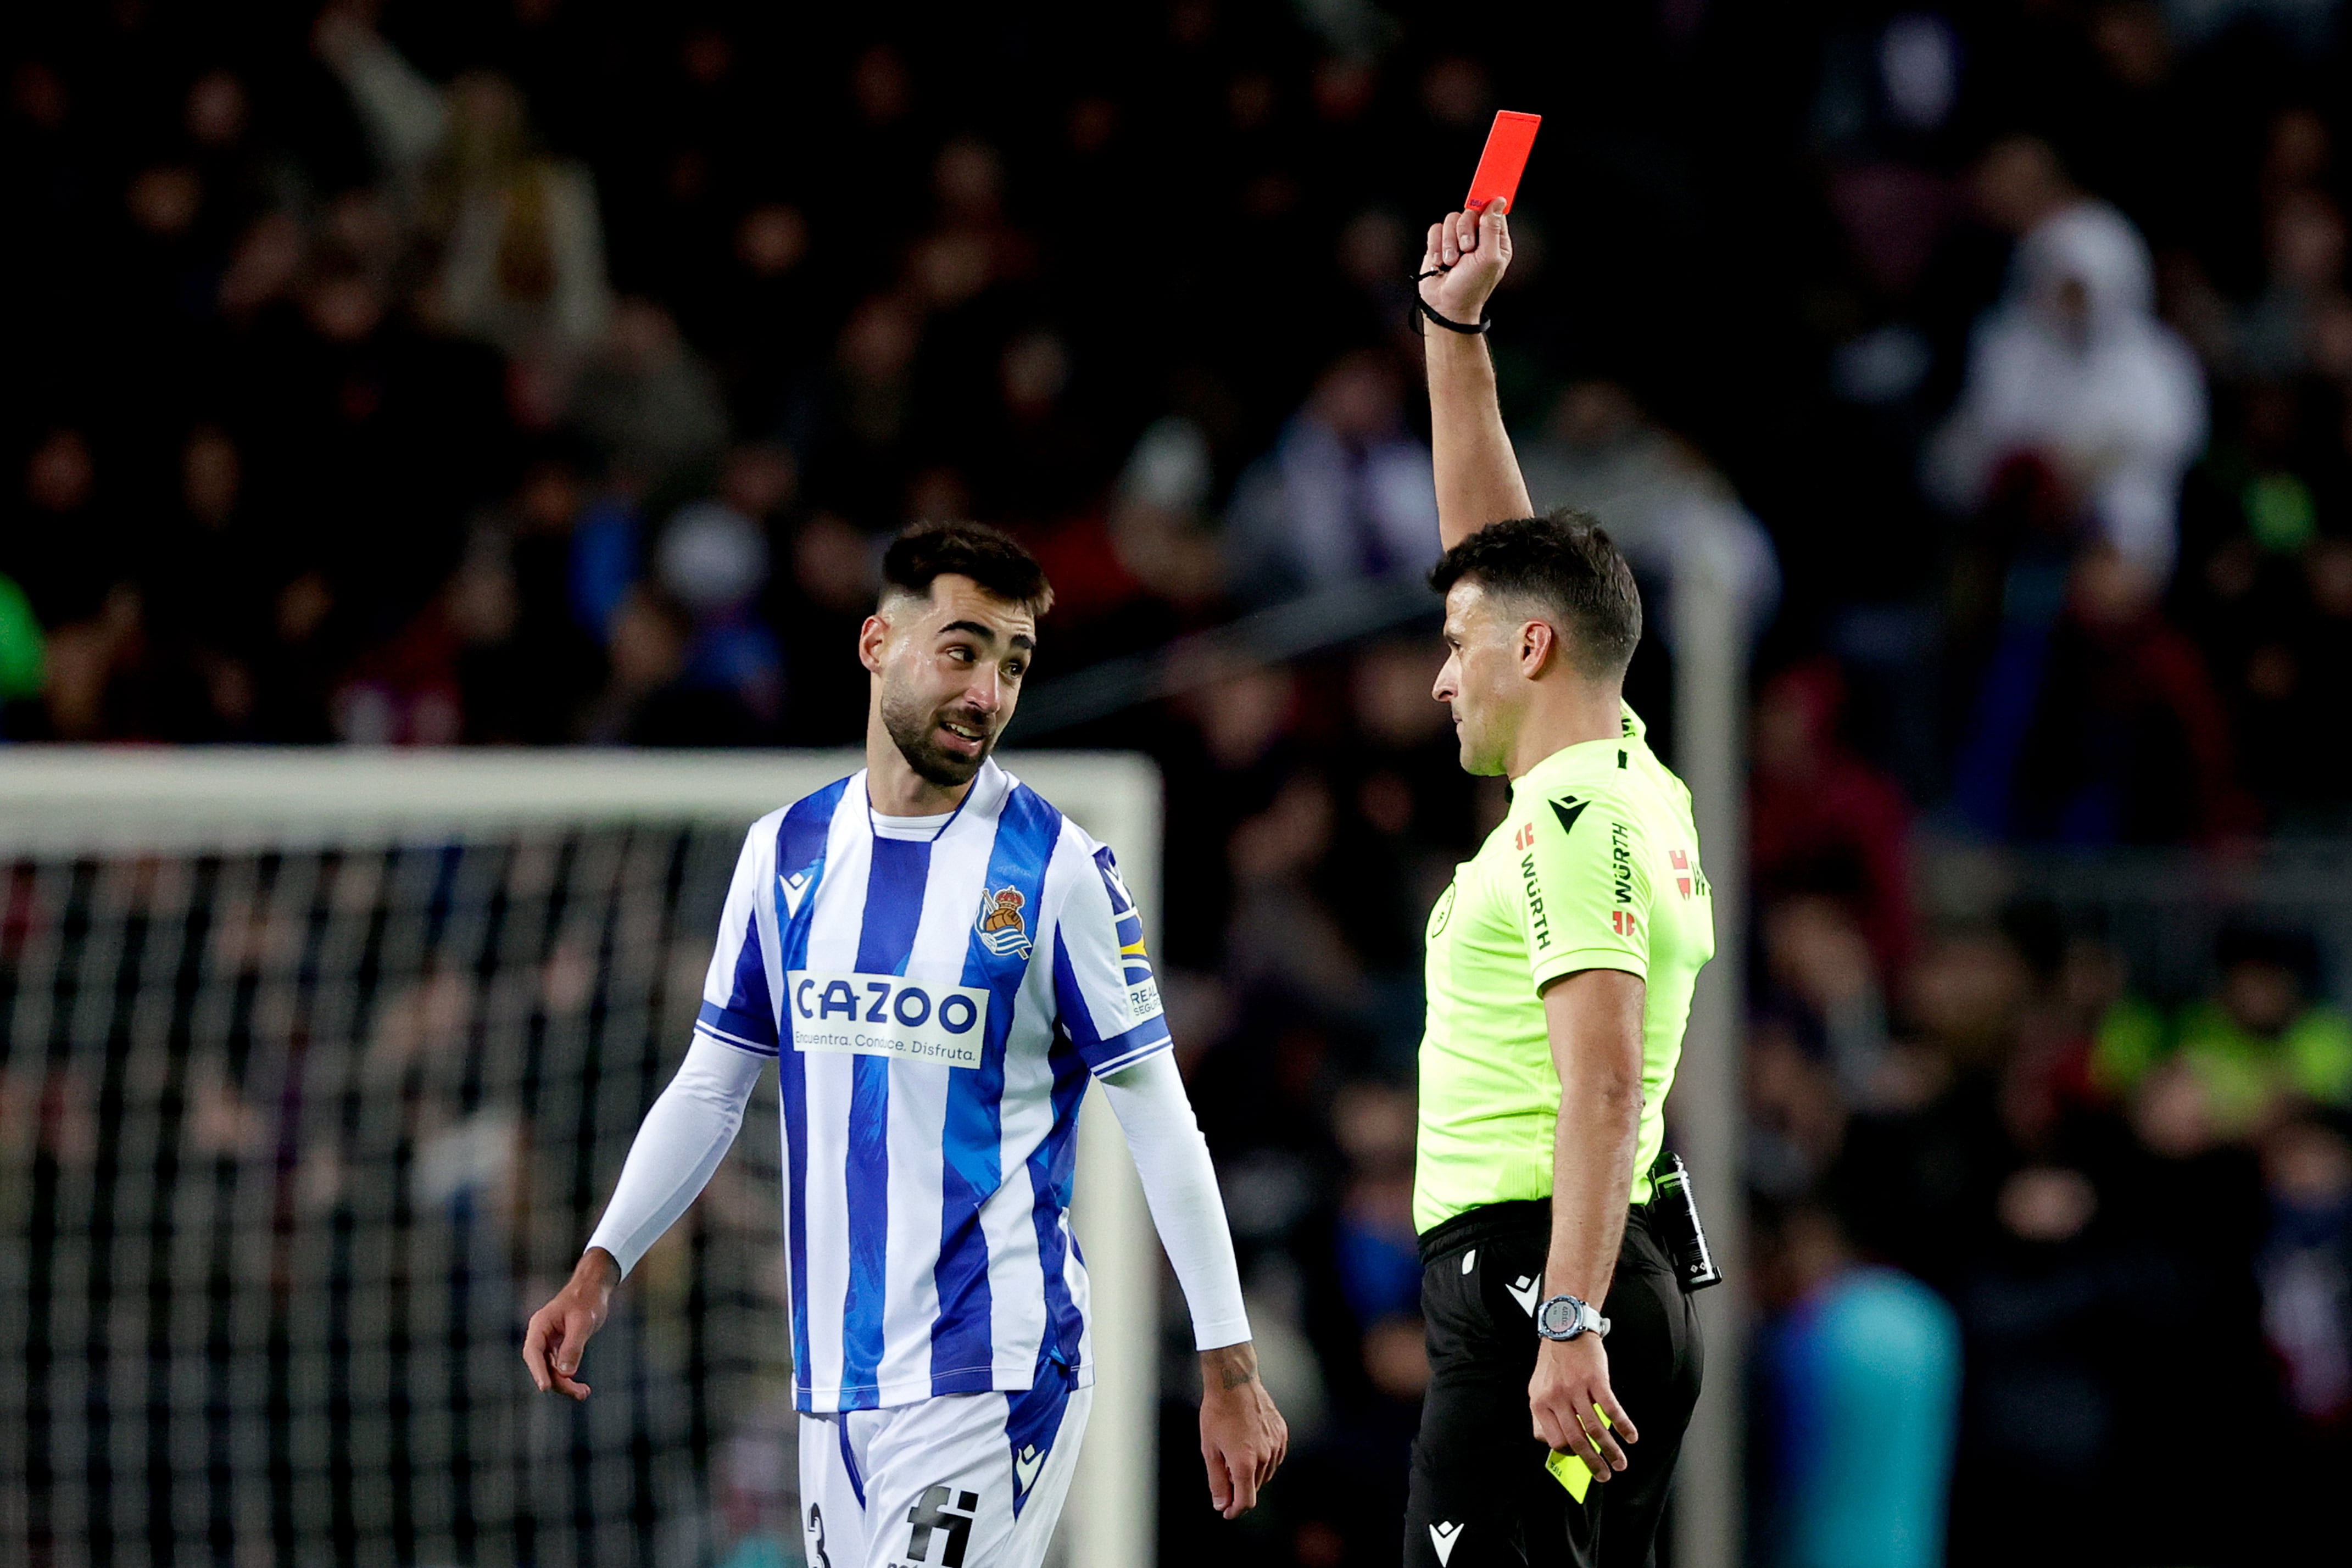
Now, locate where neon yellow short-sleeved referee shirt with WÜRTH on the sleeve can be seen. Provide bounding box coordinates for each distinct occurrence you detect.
[1413,707,1715,1232]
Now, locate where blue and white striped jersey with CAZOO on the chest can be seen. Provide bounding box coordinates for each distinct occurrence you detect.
[696,762,1169,1413]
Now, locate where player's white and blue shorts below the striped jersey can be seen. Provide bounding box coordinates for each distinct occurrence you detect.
[800,1366,1094,1568]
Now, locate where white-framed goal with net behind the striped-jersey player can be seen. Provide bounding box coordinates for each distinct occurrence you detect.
[0,747,1160,1568]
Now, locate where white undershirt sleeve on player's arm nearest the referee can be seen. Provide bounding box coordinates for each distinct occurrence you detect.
[1103,1051,1249,1349]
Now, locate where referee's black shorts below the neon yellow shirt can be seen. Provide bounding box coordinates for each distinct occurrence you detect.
[1404,1201,1701,1568]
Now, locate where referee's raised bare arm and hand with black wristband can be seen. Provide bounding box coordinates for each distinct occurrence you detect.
[1413,200,1536,550]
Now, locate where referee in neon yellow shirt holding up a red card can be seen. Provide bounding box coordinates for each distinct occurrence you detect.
[1404,202,1715,1568]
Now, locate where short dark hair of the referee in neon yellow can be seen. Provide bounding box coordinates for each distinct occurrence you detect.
[1430,508,1642,677]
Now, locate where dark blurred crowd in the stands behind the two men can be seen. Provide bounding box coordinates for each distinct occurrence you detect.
[14,0,2352,1566]
